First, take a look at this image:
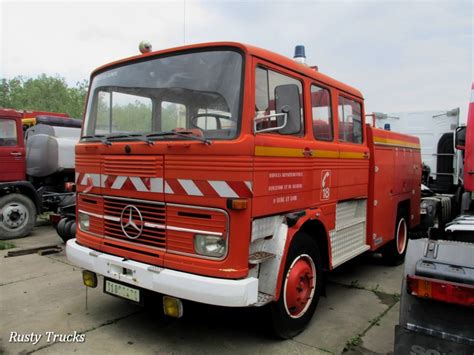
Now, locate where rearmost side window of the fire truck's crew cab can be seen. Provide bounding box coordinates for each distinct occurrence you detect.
[338,96,362,143]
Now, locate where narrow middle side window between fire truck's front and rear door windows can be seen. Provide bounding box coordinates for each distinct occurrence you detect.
[311,85,333,141]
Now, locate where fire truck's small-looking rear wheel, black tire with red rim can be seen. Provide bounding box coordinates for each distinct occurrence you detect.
[382,209,408,266]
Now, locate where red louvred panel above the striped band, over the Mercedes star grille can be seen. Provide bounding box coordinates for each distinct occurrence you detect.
[104,155,163,177]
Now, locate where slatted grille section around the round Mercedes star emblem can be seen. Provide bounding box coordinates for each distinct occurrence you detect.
[104,197,166,249]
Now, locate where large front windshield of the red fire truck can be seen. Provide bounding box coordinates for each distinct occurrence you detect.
[83,50,242,139]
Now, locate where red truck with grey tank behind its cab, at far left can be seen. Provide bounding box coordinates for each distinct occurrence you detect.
[0,109,81,239]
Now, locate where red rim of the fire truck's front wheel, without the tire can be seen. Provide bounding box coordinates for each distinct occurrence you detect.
[284,254,316,318]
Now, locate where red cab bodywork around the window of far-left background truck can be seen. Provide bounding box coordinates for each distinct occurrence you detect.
[0,109,26,182]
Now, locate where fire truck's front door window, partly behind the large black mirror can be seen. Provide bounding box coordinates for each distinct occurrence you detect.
[255,67,304,135]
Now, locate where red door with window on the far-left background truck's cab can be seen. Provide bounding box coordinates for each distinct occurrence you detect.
[0,117,26,181]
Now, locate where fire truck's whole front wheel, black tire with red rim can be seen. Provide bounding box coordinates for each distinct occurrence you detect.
[270,232,323,339]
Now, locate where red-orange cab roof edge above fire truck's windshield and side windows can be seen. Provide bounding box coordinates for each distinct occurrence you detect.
[92,42,363,99]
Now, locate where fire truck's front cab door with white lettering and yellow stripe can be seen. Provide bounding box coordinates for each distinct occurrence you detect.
[252,59,313,217]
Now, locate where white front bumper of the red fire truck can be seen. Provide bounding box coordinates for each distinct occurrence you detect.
[66,239,258,307]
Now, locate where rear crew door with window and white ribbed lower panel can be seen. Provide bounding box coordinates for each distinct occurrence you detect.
[330,92,370,267]
